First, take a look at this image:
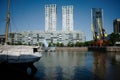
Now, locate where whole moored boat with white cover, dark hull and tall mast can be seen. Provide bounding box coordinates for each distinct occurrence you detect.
[0,0,42,64]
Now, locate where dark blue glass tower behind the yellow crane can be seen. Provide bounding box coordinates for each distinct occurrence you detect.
[91,8,104,40]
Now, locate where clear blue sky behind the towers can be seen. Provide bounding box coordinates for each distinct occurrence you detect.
[0,0,120,41]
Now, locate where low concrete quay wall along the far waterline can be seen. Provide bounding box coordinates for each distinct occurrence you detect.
[56,46,120,52]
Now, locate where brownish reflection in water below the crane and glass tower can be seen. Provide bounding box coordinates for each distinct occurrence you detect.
[93,52,107,79]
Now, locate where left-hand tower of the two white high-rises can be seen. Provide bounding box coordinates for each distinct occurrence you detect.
[45,4,57,32]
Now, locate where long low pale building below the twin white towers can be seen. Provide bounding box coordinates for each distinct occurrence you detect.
[9,31,86,46]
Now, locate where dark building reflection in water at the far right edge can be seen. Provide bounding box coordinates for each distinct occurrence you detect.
[108,52,120,80]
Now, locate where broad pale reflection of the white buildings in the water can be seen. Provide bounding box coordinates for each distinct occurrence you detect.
[33,51,85,80]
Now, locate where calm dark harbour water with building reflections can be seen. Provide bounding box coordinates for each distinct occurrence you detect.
[0,51,120,80]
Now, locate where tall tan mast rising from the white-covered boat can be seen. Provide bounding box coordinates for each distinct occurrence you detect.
[5,0,10,45]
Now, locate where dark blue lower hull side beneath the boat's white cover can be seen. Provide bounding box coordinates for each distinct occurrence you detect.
[0,54,41,64]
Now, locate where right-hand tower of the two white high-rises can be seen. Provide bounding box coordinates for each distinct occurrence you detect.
[62,5,73,31]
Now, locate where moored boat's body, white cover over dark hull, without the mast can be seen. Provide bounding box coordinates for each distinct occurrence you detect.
[0,46,42,64]
